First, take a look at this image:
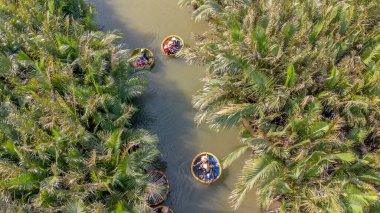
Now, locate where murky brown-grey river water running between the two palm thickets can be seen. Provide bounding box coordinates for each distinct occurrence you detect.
[90,0,260,213]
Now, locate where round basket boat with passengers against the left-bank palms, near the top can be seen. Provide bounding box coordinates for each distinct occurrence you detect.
[129,48,155,70]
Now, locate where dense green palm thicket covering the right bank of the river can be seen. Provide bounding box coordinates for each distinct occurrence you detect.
[179,0,380,212]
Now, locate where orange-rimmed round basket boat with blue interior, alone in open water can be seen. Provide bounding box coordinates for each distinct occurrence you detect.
[191,152,222,184]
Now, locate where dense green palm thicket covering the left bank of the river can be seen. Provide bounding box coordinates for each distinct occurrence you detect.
[0,0,160,212]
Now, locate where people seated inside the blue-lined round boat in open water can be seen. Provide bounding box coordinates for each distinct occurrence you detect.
[194,154,217,182]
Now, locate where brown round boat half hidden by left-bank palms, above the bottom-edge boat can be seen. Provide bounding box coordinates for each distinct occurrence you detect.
[145,170,170,206]
